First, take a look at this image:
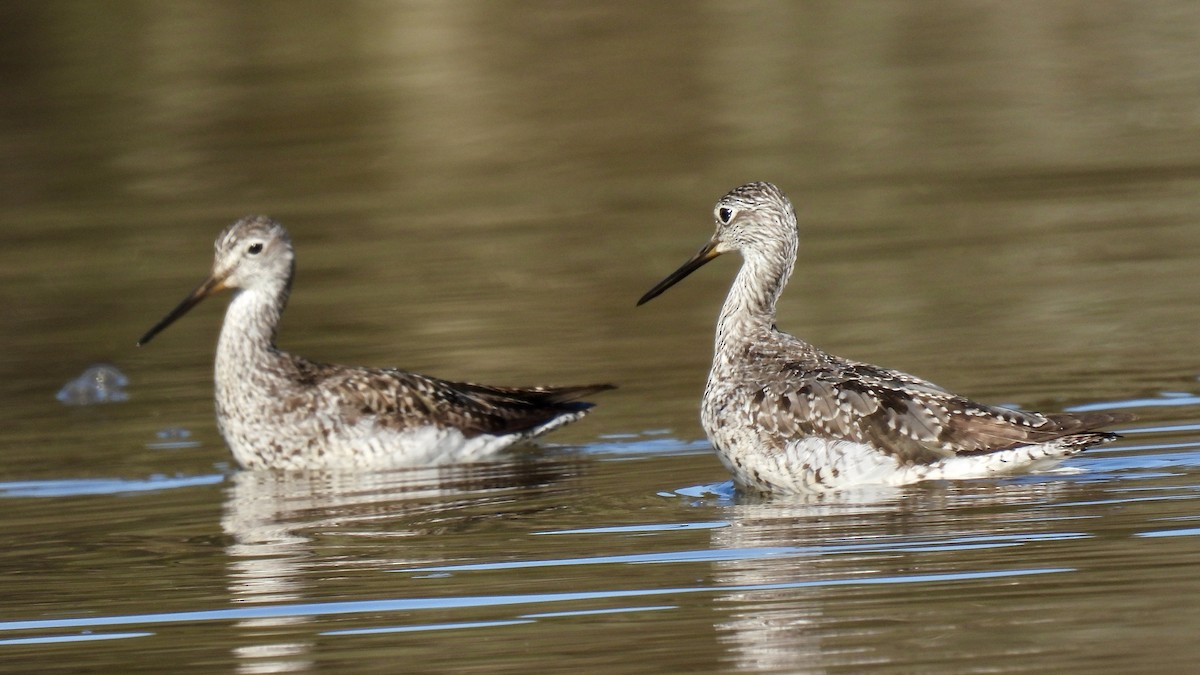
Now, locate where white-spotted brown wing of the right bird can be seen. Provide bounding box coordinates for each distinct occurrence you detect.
[756,362,1132,462]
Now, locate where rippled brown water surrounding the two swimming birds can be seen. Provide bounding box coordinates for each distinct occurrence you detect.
[0,0,1200,673]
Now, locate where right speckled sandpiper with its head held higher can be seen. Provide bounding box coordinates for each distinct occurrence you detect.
[637,181,1134,494]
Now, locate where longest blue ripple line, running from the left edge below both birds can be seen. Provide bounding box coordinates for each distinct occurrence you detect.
[0,567,1074,631]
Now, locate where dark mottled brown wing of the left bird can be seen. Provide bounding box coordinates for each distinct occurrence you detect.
[312,364,613,436]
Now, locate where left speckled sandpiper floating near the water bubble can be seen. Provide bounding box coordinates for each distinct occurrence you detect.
[137,215,613,471]
